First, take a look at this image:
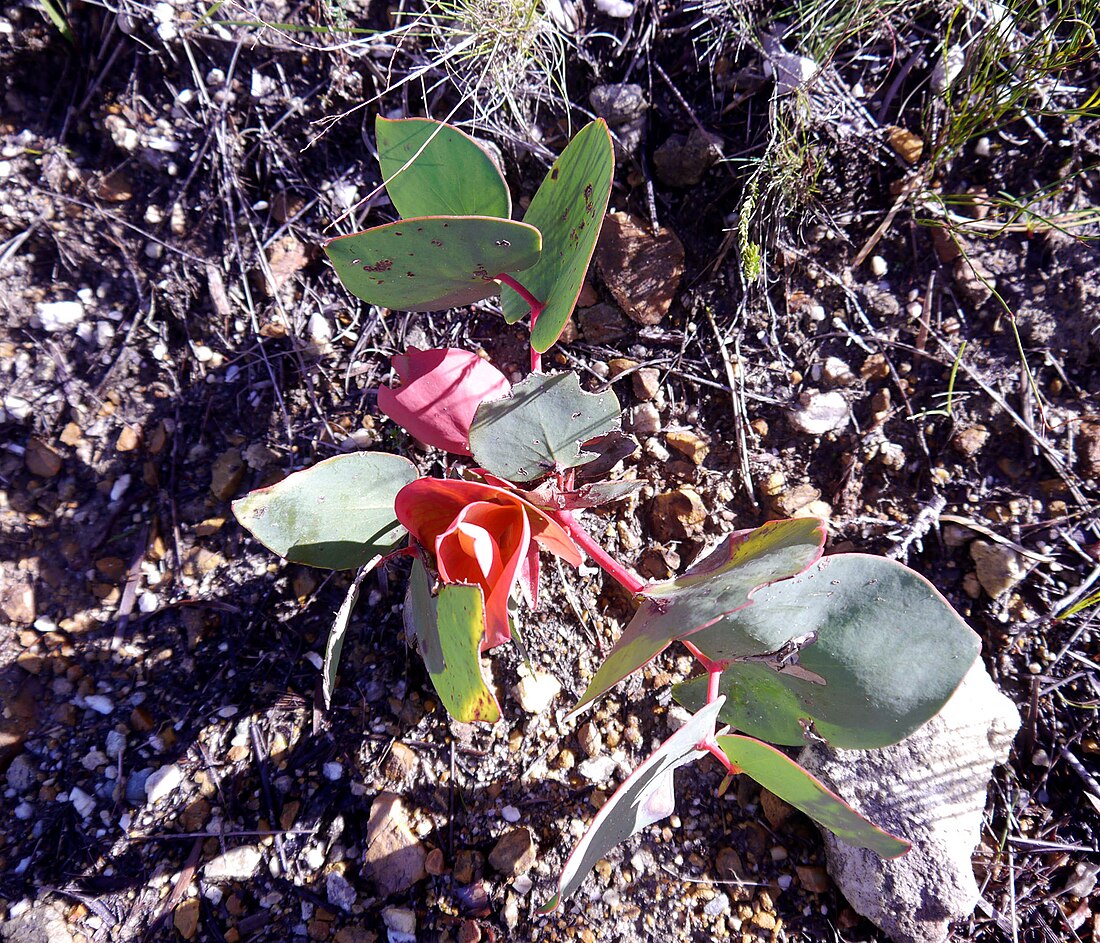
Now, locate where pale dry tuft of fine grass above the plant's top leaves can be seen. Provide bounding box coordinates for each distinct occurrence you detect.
[393,0,569,130]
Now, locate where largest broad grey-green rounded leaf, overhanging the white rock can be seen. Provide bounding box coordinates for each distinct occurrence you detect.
[674,553,980,749]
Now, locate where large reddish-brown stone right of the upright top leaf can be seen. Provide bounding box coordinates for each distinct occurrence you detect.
[596,212,684,325]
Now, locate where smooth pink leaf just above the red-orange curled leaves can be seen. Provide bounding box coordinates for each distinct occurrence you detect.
[378,347,512,456]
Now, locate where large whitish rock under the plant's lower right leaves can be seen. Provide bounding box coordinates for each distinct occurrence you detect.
[799,661,1020,943]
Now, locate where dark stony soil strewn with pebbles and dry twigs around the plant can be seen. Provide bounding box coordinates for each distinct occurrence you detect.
[0,0,1100,943]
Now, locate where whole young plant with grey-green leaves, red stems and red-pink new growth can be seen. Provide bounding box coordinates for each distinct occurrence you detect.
[233,118,979,911]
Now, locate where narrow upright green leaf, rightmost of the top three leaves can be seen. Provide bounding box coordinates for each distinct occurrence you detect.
[501,119,615,353]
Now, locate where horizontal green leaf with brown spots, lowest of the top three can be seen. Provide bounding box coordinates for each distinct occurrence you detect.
[325,216,542,311]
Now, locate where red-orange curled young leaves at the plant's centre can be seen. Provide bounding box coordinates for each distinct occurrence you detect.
[394,478,581,650]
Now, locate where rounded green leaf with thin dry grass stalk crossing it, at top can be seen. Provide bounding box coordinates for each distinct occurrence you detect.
[374,114,512,218]
